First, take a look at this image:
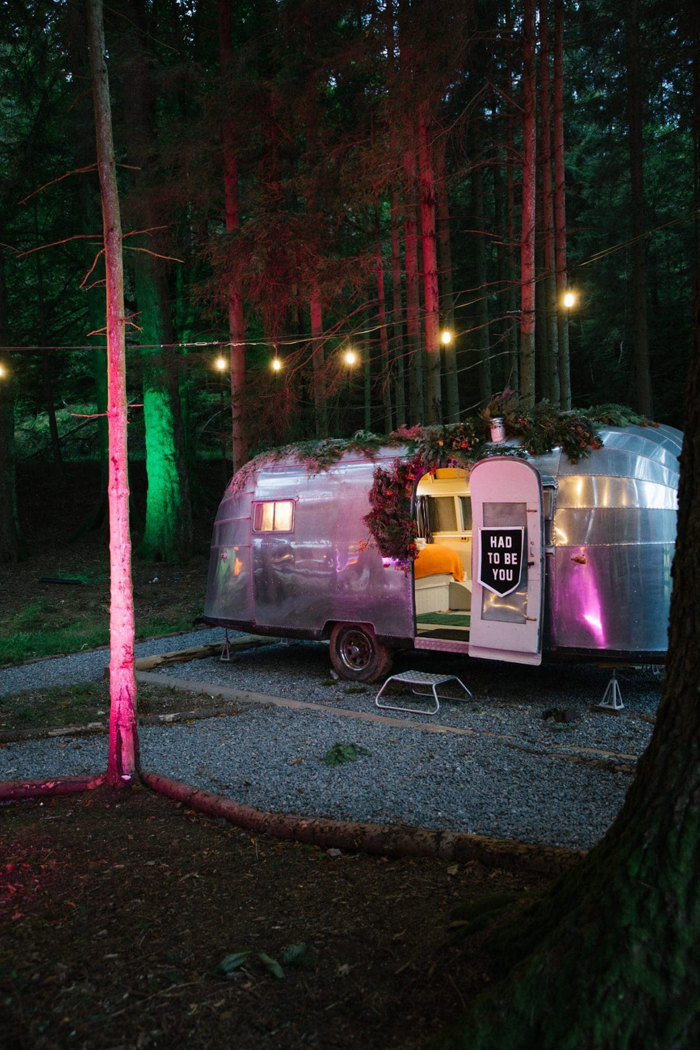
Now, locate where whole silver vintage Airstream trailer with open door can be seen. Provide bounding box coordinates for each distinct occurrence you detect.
[203,425,681,681]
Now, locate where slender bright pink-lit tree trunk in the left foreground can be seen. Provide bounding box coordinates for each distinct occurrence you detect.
[87,0,139,786]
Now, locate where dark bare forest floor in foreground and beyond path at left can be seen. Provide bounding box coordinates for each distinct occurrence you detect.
[0,467,553,1050]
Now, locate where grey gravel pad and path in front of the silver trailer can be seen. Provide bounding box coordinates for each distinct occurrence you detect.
[0,631,661,848]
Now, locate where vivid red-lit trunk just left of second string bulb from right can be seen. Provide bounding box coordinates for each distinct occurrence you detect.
[418,102,442,423]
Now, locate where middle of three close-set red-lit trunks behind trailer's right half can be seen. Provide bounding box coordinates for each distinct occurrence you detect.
[539,0,561,408]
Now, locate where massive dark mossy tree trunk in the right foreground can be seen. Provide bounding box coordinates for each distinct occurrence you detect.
[443,282,700,1050]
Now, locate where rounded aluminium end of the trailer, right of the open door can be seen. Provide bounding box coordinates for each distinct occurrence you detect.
[547,426,682,657]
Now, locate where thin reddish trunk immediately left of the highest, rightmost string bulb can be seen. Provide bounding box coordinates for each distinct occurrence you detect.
[553,0,571,412]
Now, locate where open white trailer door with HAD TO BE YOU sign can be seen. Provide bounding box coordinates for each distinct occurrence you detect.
[469,456,544,664]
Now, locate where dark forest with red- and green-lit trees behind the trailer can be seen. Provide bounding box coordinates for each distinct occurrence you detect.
[0,0,698,559]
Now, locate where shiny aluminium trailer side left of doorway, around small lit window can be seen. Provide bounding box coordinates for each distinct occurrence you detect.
[205,450,413,639]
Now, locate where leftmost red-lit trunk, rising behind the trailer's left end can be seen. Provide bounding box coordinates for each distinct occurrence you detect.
[218,0,248,471]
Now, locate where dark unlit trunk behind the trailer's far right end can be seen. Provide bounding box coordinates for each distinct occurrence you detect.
[625,0,654,417]
